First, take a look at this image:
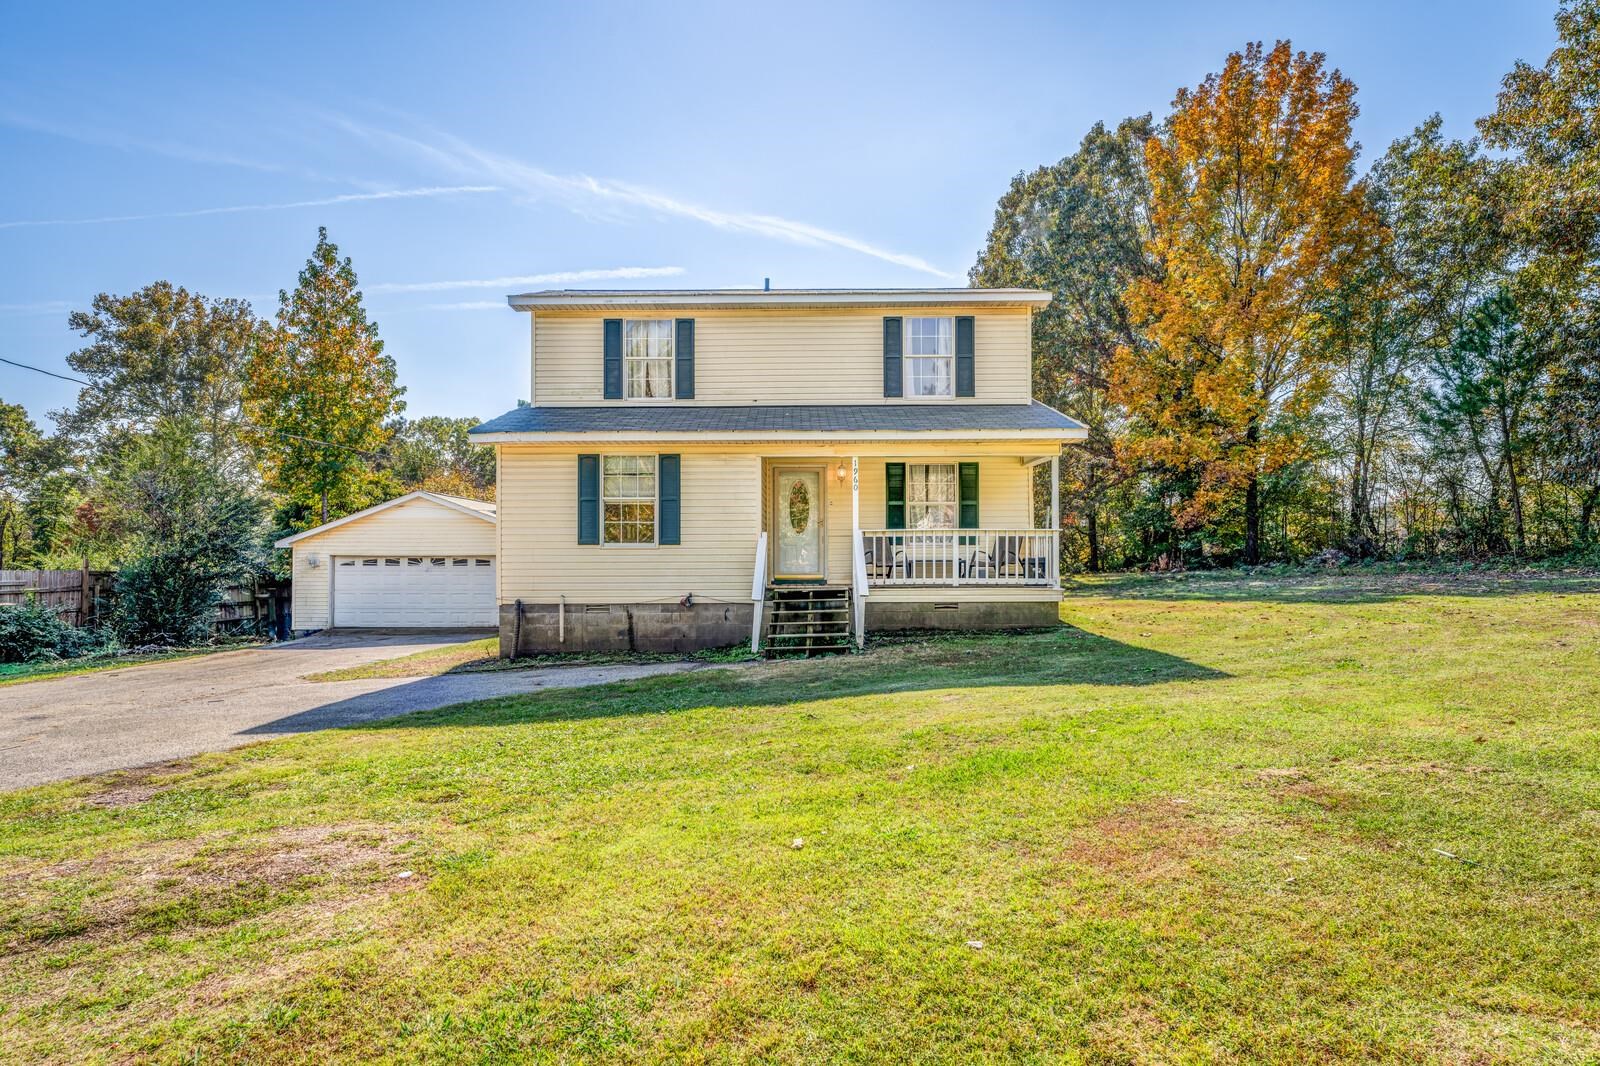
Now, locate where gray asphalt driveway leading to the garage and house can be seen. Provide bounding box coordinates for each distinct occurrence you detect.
[0,632,699,789]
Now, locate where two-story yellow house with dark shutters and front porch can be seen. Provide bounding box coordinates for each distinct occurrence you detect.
[472,288,1085,655]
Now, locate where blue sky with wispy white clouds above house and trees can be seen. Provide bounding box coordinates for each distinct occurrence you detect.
[0,0,1555,423]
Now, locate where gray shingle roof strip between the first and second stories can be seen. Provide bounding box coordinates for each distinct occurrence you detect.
[472,400,1083,437]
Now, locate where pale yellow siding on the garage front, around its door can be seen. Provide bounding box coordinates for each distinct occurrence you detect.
[290,499,494,629]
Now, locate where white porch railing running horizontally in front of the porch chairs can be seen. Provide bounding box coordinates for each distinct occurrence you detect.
[861,530,1061,587]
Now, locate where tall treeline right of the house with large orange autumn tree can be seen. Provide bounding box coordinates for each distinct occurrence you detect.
[971,0,1600,570]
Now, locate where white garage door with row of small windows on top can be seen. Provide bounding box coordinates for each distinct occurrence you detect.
[333,555,499,629]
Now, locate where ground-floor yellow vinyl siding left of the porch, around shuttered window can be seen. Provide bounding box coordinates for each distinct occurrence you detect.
[499,445,762,603]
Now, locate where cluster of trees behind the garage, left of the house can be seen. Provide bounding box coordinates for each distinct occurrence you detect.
[0,230,494,642]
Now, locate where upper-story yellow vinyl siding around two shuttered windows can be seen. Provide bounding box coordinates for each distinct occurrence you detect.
[533,307,1032,407]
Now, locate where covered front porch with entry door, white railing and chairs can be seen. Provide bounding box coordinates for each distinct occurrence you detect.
[750,453,1061,650]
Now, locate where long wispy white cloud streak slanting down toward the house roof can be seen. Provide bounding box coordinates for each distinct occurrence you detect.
[323,114,960,280]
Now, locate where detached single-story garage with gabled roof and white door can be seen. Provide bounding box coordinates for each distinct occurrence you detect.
[277,491,499,632]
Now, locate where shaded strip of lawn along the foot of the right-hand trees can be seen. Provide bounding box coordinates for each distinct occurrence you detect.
[1066,570,1600,603]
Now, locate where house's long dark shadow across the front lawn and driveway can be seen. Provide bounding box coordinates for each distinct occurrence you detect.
[248,626,1227,733]
